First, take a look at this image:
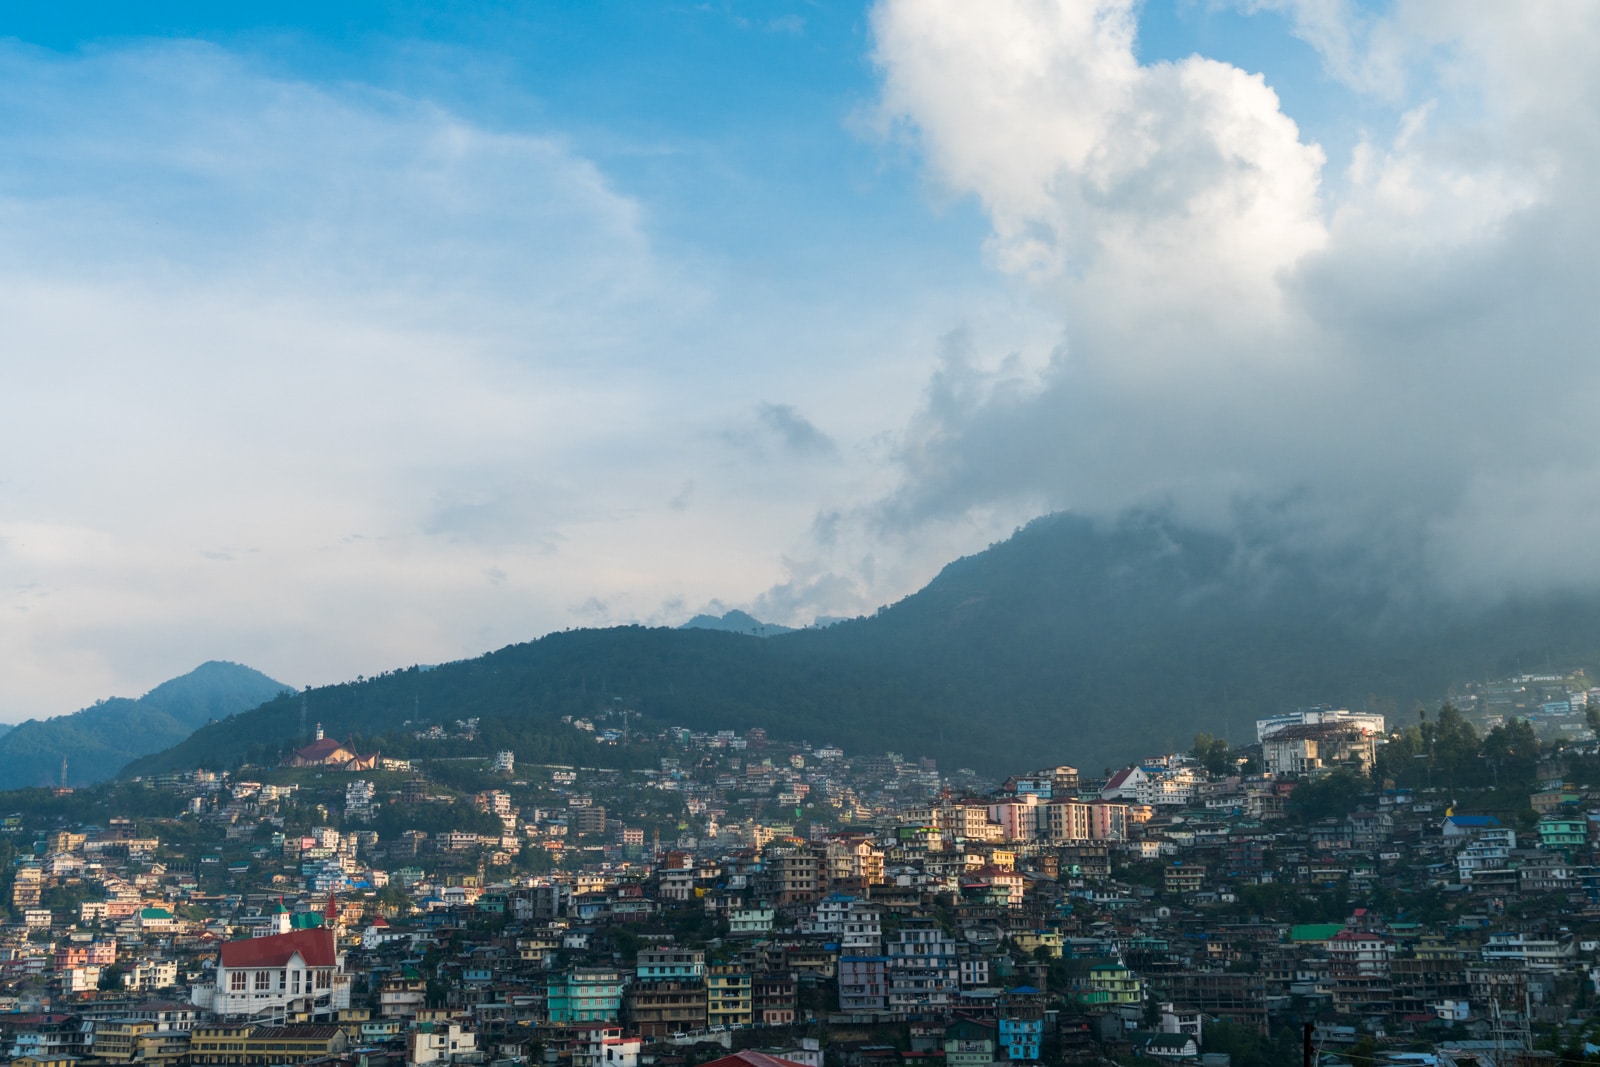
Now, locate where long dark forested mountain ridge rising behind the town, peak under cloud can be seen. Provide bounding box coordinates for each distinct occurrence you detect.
[126,514,1600,773]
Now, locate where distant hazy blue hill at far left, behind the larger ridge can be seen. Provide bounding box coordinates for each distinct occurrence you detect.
[0,661,288,789]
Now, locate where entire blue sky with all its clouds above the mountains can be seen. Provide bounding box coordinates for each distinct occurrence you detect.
[0,0,1600,721]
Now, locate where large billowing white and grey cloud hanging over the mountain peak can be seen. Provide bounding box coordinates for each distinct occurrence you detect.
[872,0,1600,592]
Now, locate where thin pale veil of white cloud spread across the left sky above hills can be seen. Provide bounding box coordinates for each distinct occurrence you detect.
[0,43,934,718]
